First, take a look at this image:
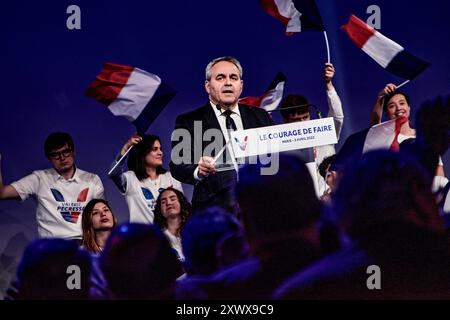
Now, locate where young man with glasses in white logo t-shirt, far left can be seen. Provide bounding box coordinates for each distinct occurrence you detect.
[0,132,104,240]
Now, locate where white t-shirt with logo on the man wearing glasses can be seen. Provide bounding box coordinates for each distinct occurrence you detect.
[11,168,104,239]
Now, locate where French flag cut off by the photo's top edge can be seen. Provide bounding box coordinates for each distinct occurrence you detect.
[260,0,325,36]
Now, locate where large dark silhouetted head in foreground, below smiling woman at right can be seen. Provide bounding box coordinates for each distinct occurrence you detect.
[333,151,443,239]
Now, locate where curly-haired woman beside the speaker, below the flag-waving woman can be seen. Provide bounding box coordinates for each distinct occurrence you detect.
[155,188,192,261]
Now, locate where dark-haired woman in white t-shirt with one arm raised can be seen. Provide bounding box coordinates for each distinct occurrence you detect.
[109,134,183,223]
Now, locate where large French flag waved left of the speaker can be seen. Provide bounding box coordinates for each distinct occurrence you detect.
[85,63,176,135]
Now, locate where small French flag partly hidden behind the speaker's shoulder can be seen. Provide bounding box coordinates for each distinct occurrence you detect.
[239,72,286,112]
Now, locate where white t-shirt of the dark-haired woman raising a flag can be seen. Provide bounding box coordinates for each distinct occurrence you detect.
[123,170,183,223]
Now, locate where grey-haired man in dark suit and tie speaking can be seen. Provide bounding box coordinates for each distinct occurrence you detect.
[170,57,273,214]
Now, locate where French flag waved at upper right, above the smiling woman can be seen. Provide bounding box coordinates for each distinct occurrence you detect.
[341,15,430,80]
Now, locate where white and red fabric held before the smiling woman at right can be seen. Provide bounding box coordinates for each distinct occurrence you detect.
[363,117,408,153]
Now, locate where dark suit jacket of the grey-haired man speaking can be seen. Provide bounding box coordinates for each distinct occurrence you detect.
[170,102,273,210]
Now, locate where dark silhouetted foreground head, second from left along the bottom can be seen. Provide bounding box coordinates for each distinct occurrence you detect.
[101,223,182,299]
